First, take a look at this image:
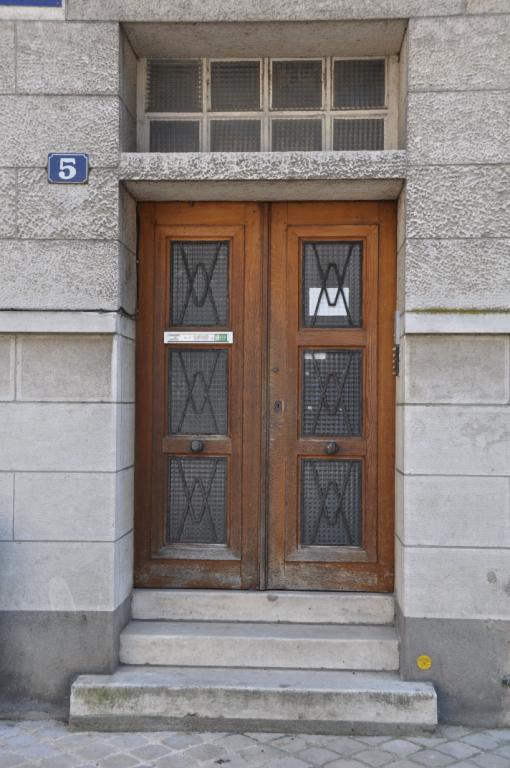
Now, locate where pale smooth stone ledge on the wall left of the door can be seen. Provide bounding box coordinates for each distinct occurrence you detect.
[0,310,135,339]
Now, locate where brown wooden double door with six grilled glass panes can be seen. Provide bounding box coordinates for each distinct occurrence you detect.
[135,202,395,591]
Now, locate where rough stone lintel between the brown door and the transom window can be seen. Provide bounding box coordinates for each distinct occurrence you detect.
[119,150,407,201]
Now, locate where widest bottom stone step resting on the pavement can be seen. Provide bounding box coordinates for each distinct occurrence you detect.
[70,667,437,734]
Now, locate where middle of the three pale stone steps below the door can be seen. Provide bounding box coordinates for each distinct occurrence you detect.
[120,621,399,670]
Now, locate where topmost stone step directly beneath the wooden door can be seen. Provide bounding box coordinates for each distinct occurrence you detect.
[132,589,395,624]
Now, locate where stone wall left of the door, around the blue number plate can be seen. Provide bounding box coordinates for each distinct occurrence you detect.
[0,15,136,704]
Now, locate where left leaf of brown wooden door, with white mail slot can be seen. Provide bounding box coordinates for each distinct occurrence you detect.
[136,204,262,588]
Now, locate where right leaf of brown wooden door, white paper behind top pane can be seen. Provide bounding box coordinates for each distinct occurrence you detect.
[268,203,395,590]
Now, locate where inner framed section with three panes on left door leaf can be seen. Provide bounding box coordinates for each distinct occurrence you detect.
[151,224,244,568]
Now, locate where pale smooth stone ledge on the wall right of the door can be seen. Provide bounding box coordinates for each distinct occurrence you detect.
[401,310,510,334]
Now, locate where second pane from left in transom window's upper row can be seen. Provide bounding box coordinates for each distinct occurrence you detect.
[211,61,260,112]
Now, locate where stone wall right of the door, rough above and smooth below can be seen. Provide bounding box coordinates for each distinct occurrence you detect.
[397,9,510,724]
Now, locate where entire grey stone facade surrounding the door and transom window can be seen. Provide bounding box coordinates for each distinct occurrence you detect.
[0,0,510,725]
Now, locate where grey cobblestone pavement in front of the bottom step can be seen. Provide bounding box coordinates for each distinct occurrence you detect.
[0,721,510,768]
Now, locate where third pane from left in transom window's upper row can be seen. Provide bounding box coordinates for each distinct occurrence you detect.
[271,61,322,109]
